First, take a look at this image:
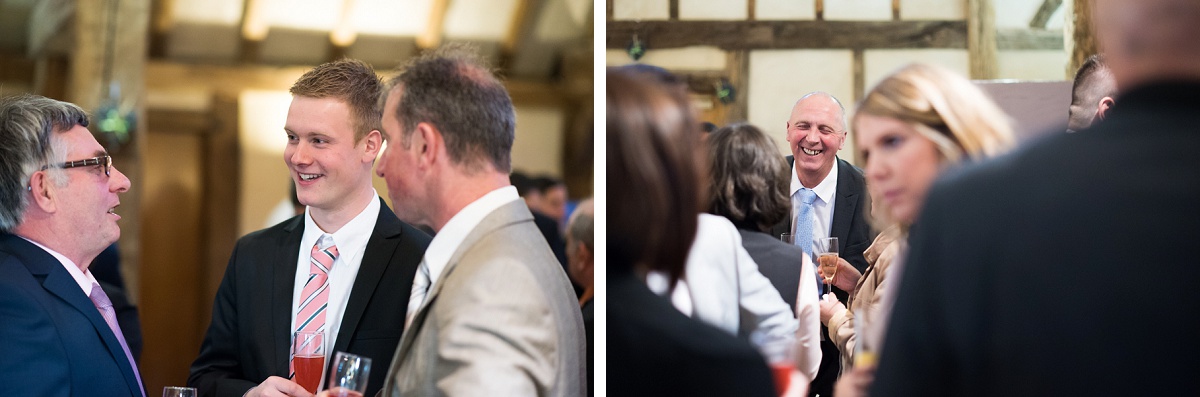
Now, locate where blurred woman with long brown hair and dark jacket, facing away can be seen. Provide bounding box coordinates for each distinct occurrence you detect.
[605,68,775,396]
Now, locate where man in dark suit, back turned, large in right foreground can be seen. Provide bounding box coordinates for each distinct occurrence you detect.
[871,0,1200,396]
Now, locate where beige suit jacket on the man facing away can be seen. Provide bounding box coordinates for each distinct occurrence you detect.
[380,200,587,397]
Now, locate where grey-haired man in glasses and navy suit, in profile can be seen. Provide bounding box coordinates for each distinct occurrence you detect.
[0,95,145,396]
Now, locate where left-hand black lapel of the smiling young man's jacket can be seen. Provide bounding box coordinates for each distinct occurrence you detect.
[273,216,304,377]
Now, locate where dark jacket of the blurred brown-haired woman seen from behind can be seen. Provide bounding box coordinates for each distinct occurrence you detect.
[605,265,775,397]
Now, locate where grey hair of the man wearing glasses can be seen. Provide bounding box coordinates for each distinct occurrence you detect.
[0,95,88,231]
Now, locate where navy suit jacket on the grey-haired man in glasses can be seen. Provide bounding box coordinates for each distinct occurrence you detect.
[0,233,143,397]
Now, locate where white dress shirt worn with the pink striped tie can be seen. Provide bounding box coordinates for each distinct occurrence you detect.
[289,193,379,364]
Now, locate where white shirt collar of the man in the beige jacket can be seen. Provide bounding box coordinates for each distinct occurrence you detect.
[425,185,521,285]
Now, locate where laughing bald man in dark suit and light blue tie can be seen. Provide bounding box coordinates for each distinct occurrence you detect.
[772,91,875,396]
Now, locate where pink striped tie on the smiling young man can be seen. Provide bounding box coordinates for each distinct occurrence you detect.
[288,235,337,378]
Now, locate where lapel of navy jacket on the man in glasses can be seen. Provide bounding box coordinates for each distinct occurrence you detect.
[2,234,144,396]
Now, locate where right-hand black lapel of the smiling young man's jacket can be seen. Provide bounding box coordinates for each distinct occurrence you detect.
[330,199,416,353]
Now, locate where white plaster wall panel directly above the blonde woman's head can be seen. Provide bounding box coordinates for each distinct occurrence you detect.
[862,49,971,94]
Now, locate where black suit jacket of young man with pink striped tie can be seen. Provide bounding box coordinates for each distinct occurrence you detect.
[187,199,431,396]
